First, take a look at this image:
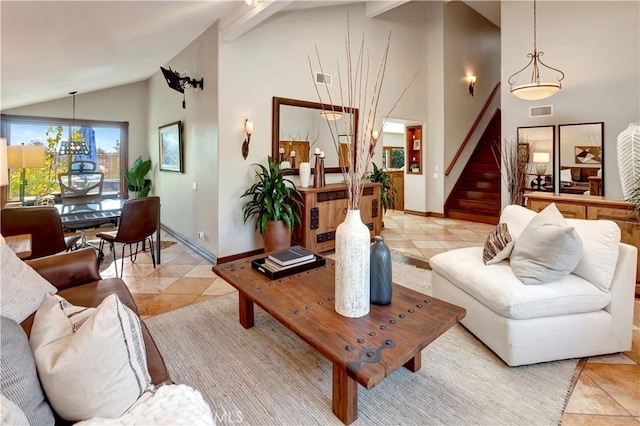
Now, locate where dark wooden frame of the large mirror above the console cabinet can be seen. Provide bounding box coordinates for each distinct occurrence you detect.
[271,96,359,174]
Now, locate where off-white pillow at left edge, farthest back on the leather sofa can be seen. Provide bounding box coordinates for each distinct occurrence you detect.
[0,236,58,323]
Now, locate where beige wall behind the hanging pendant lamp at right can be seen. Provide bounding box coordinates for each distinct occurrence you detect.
[501,1,640,199]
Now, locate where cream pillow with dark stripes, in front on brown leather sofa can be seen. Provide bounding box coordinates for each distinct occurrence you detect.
[30,294,151,421]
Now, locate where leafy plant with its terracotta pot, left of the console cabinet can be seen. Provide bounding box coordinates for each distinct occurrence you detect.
[240,156,302,252]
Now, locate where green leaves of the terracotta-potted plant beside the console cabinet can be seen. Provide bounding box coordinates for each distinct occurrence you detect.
[240,156,302,235]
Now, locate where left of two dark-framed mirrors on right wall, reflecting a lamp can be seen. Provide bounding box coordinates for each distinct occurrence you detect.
[518,126,556,192]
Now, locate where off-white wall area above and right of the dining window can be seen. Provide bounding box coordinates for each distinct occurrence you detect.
[2,81,149,163]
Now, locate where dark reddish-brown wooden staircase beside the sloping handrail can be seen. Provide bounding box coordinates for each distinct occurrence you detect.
[444,109,501,224]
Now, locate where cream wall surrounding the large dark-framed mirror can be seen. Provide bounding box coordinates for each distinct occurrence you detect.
[216,3,426,256]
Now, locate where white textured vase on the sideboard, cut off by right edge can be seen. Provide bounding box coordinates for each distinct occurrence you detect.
[617,123,640,198]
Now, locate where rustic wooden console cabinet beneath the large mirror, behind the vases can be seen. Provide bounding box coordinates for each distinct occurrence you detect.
[292,183,382,253]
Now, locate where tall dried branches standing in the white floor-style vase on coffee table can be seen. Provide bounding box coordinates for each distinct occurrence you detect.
[308,15,418,210]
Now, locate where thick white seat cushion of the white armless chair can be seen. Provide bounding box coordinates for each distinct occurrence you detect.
[429,243,611,319]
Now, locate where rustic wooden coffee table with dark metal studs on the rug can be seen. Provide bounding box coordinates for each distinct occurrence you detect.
[213,255,466,424]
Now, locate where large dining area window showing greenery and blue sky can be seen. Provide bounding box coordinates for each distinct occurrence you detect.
[2,115,129,200]
